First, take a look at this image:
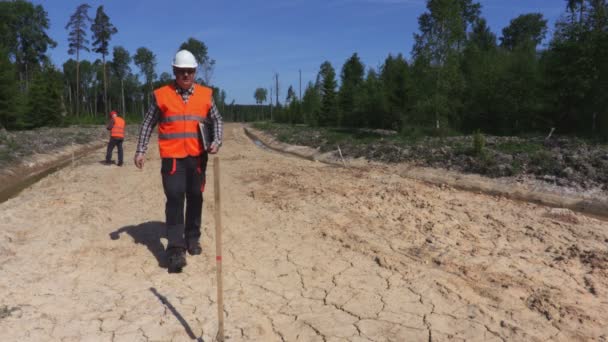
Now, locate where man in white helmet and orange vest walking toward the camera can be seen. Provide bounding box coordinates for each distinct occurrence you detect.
[134,50,223,272]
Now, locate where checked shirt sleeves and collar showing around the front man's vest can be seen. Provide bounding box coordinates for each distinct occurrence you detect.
[137,85,224,153]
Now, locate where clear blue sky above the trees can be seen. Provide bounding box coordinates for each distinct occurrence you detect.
[32,0,566,104]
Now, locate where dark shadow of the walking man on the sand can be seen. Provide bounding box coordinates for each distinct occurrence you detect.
[110,221,167,268]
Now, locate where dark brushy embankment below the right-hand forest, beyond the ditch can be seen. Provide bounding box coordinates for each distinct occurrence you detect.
[258,124,608,192]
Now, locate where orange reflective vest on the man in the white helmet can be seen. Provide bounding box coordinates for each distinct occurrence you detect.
[154,84,213,158]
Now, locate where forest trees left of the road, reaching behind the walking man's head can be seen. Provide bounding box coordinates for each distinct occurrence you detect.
[0,0,226,129]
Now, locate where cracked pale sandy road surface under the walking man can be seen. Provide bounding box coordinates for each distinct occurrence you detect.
[0,124,608,341]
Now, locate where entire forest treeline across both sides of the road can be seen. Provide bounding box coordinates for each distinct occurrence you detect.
[0,0,608,139]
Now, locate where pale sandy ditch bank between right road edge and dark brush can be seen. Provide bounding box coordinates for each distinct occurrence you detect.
[245,127,608,219]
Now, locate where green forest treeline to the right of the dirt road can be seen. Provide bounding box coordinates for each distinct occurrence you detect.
[255,0,608,140]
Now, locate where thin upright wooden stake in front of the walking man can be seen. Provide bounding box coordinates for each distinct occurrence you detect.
[213,157,224,342]
